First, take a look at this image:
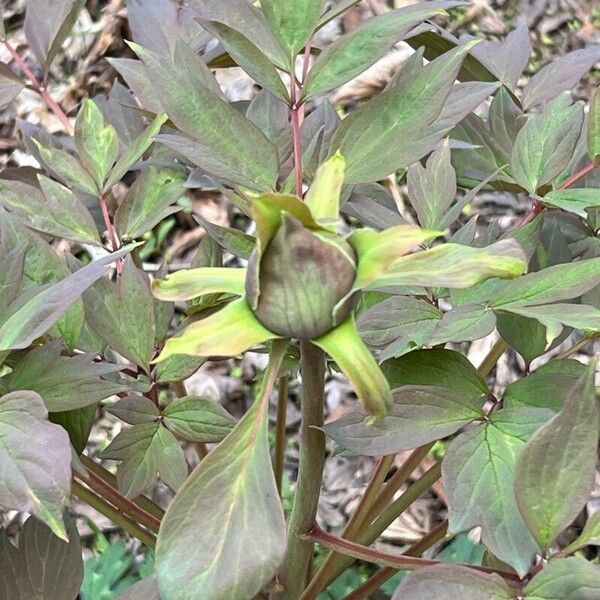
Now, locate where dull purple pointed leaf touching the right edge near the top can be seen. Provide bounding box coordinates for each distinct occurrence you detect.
[522,46,600,110]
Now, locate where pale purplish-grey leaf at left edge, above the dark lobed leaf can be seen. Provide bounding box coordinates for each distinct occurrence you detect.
[0,391,71,539]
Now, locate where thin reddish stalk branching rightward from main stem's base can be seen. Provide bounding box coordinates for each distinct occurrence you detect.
[302,526,521,582]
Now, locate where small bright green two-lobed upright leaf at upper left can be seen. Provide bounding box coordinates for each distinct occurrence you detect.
[75,98,119,189]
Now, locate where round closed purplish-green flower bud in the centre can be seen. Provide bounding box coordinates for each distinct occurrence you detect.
[246,212,356,339]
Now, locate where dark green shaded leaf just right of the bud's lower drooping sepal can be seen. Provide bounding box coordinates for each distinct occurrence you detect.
[381,348,489,401]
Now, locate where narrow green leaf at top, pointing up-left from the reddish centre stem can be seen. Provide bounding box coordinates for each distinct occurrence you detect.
[198,18,289,103]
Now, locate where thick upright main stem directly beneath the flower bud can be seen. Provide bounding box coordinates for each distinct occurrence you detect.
[270,340,325,600]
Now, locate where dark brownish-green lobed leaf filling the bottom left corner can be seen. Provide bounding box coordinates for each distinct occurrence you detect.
[0,515,83,600]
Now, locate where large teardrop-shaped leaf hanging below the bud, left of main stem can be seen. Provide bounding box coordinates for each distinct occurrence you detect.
[156,343,286,600]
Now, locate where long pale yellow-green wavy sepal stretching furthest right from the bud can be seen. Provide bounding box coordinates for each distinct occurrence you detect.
[369,239,527,289]
